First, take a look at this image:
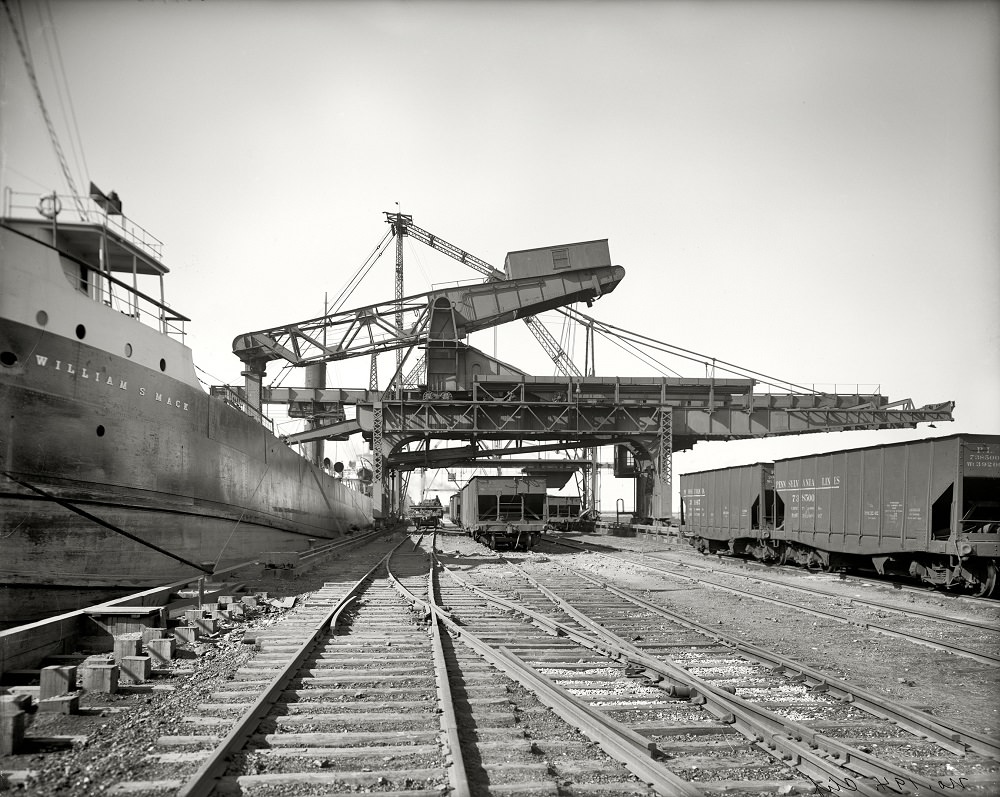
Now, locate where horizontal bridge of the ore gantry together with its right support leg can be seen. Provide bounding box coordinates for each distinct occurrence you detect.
[266,375,954,519]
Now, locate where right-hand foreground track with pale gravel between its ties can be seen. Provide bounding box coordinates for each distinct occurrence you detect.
[438,532,1000,794]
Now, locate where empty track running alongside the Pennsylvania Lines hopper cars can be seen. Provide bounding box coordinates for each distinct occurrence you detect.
[539,538,1000,667]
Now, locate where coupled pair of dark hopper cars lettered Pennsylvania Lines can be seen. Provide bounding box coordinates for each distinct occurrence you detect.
[681,434,1000,596]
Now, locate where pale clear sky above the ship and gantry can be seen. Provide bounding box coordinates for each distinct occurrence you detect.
[0,0,1000,511]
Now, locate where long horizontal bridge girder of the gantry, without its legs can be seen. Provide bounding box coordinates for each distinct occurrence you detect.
[264,376,954,450]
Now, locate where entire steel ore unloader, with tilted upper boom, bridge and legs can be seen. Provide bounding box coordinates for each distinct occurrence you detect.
[233,213,954,519]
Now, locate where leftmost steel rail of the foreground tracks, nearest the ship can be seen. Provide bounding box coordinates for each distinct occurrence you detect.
[176,538,405,797]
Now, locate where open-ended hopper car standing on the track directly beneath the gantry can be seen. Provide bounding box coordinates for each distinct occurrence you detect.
[459,476,546,551]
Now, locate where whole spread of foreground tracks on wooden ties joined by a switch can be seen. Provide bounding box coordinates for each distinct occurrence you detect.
[103,535,1000,797]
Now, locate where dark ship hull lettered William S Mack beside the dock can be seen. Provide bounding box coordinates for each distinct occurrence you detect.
[0,221,372,625]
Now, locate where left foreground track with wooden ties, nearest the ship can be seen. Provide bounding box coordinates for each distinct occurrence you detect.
[111,539,680,797]
